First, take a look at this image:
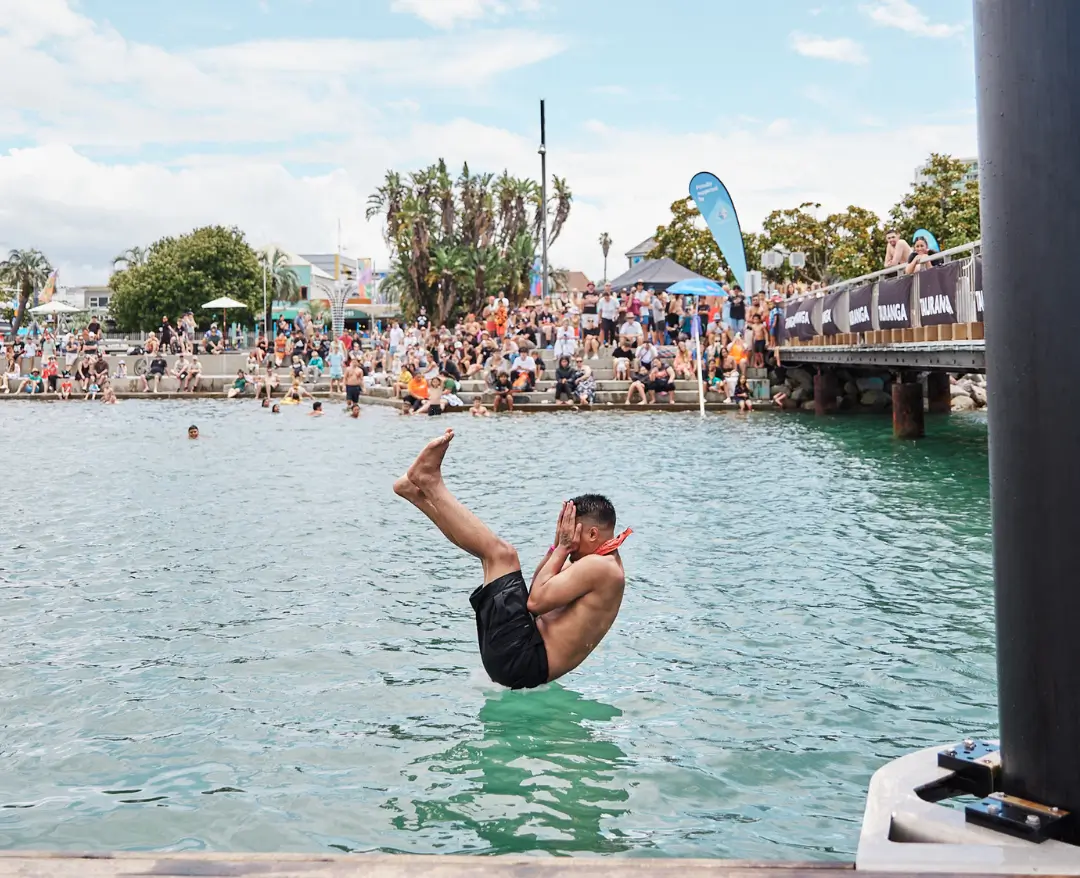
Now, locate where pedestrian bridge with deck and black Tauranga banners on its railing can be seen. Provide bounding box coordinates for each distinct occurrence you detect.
[779,241,986,373]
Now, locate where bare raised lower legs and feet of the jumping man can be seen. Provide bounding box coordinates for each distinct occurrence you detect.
[394,430,522,584]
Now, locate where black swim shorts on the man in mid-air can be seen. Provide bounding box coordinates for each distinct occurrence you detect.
[469,570,548,689]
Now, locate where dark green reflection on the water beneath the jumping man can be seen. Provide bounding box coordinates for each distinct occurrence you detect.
[386,684,630,853]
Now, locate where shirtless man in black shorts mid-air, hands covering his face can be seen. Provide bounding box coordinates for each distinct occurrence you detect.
[394,430,631,689]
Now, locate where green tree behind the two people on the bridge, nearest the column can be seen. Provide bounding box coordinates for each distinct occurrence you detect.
[889,152,982,249]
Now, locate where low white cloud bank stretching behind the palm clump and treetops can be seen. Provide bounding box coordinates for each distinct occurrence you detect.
[0,112,975,284]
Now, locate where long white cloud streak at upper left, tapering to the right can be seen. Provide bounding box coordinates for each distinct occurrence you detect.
[0,0,566,148]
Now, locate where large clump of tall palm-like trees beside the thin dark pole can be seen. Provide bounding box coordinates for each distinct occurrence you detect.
[367,160,572,324]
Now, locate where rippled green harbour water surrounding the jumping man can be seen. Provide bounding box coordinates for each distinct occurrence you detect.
[0,401,997,860]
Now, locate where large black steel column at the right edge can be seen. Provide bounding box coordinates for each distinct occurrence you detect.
[974,0,1080,841]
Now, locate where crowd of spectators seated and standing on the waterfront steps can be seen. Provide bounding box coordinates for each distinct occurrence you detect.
[3,271,842,414]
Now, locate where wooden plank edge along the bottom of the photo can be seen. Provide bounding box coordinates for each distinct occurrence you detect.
[0,851,1049,878]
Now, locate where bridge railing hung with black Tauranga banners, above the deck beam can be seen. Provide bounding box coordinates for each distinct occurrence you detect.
[782,241,983,345]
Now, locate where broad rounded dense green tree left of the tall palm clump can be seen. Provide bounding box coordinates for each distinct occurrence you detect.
[109,226,262,330]
